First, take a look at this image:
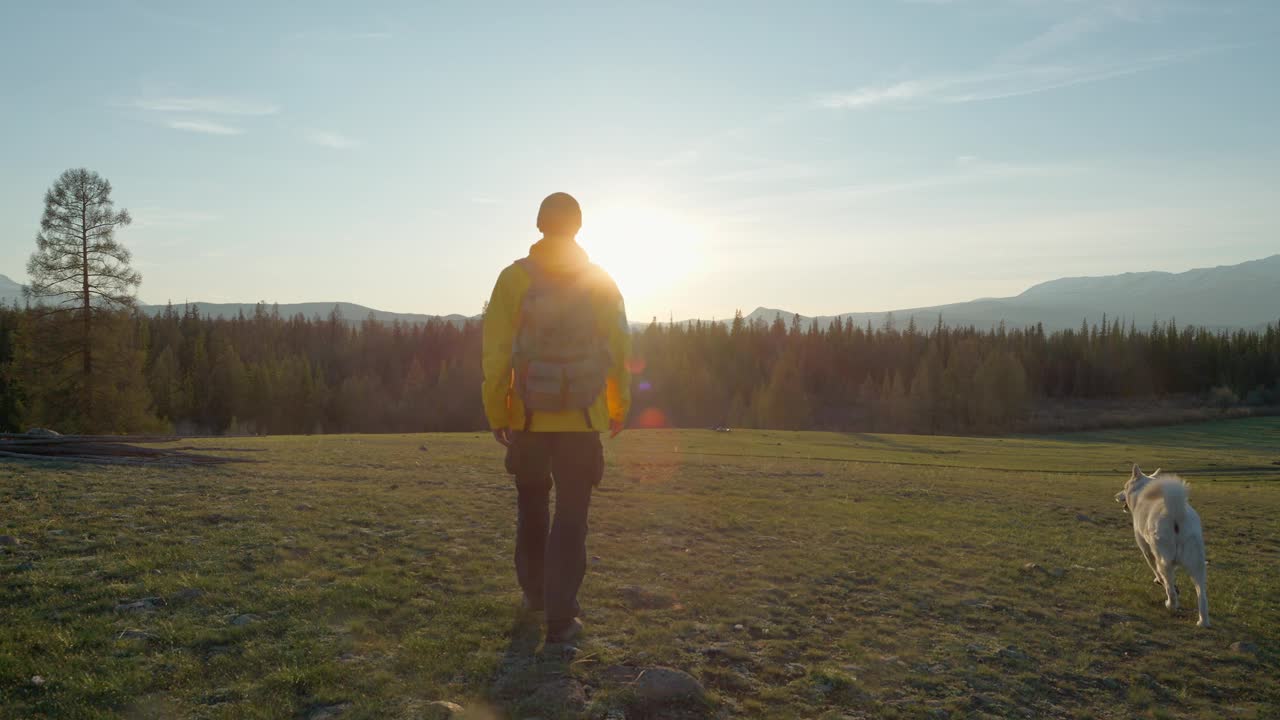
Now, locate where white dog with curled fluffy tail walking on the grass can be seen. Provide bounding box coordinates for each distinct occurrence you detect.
[1116,465,1208,628]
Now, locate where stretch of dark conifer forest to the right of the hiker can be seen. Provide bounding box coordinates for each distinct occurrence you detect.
[635,313,1280,433]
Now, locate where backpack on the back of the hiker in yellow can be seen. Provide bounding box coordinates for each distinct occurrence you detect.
[511,258,612,430]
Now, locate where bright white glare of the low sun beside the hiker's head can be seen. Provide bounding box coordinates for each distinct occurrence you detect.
[580,204,704,313]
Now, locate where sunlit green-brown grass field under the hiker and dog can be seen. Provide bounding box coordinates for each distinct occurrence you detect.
[0,419,1280,720]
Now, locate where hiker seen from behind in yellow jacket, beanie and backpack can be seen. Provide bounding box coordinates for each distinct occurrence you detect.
[481,192,631,643]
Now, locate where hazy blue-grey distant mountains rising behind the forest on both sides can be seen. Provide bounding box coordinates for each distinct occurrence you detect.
[0,255,1280,331]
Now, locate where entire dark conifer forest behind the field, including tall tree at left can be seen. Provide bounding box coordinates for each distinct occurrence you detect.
[0,169,1280,434]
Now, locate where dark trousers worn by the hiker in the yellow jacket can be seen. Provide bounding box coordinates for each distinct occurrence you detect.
[507,432,604,628]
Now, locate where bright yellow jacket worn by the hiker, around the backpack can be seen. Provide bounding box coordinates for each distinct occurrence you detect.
[480,238,631,433]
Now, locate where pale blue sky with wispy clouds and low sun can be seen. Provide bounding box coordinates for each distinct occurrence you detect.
[0,0,1280,322]
